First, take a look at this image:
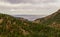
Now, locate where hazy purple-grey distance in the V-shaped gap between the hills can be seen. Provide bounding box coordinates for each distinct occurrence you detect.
[13,15,47,21]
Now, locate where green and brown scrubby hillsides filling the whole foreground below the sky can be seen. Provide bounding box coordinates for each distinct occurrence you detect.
[0,10,60,37]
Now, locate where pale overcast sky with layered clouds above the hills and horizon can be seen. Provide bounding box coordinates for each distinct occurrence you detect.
[0,0,60,15]
